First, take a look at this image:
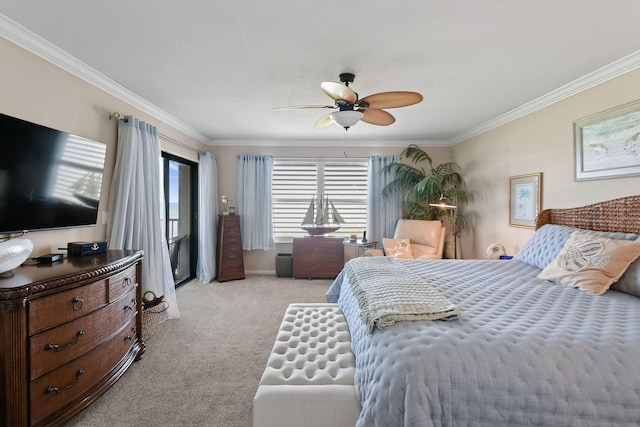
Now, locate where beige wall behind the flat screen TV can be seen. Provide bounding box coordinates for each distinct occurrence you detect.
[0,38,208,256]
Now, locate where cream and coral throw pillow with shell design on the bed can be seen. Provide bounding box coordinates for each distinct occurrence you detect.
[538,231,640,295]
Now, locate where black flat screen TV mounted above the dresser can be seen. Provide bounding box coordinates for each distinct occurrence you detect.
[0,114,107,234]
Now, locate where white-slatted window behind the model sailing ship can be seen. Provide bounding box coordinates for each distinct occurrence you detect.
[272,158,368,243]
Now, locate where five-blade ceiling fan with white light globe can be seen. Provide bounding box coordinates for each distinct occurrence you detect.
[275,73,422,129]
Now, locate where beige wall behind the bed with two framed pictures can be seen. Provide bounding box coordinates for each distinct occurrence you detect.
[453,70,640,258]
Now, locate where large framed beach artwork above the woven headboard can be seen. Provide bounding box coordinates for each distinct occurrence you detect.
[574,100,640,181]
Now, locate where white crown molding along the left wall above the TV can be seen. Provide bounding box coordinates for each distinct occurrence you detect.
[0,14,213,145]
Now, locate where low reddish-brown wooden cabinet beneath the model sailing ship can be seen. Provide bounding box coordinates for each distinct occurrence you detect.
[293,237,344,279]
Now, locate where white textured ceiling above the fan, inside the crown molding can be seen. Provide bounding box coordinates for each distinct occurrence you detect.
[0,0,640,144]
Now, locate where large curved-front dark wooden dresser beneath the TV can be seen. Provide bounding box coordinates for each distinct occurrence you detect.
[0,251,145,426]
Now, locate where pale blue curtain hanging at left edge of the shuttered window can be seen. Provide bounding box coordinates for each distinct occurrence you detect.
[236,154,276,251]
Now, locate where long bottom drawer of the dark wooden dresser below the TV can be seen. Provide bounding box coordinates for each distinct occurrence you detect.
[29,318,136,424]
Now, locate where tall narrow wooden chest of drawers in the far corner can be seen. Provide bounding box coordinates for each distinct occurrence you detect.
[217,215,244,282]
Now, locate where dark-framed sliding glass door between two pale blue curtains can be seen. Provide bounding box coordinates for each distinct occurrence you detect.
[162,153,198,287]
